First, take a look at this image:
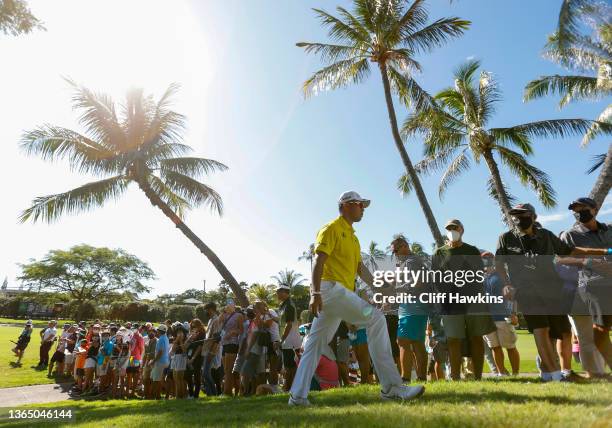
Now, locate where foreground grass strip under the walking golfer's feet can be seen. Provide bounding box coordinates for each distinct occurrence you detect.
[5,378,612,428]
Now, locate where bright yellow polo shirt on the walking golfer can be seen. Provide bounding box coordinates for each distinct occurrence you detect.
[315,216,361,291]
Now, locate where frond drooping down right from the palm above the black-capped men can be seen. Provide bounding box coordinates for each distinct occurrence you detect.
[497,147,557,208]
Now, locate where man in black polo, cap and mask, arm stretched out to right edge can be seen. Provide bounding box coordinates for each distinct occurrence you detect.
[495,204,612,380]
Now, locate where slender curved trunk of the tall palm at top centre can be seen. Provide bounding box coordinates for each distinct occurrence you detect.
[380,63,444,246]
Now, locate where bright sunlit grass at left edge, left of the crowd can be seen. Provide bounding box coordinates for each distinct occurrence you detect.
[0,327,70,388]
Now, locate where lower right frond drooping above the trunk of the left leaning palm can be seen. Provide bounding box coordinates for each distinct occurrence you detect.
[161,170,223,215]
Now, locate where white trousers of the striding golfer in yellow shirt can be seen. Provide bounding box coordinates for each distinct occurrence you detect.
[291,281,402,398]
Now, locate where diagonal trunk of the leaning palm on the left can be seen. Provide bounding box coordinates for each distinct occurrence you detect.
[137,180,249,307]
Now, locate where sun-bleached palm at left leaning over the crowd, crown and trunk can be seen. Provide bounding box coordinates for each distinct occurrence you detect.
[20,81,248,305]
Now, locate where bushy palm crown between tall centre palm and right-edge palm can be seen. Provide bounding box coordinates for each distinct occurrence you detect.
[398,61,604,224]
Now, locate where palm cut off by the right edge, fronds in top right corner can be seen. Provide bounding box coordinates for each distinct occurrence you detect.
[524,0,612,205]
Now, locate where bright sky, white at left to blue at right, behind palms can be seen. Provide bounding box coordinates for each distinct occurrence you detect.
[0,0,612,293]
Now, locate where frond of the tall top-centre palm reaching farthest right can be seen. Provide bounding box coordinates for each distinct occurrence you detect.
[402,17,471,52]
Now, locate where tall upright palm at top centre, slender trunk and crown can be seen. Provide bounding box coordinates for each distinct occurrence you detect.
[297,0,470,244]
